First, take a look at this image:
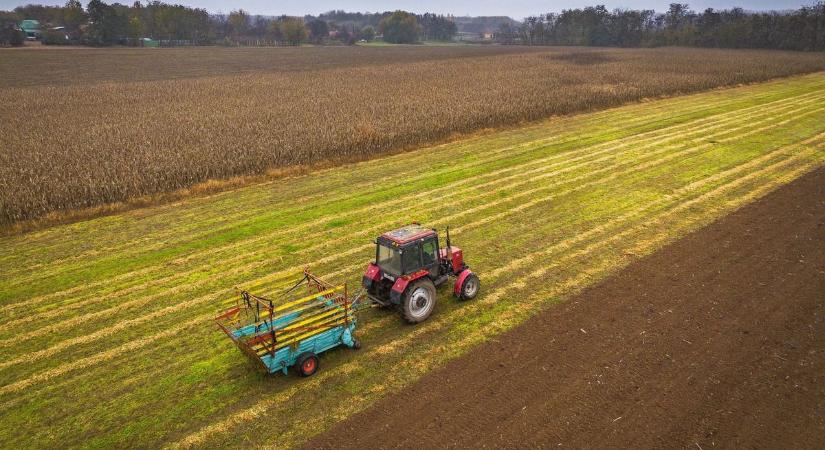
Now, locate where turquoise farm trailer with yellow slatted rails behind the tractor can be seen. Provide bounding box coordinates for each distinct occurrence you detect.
[215,270,360,377]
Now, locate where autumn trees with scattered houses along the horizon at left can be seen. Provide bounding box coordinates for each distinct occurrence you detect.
[0,0,457,46]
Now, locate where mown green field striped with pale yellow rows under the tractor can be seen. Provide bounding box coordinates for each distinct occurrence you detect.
[0,73,825,448]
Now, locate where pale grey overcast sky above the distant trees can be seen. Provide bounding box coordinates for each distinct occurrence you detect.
[0,0,815,19]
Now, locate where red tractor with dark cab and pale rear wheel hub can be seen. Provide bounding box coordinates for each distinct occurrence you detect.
[363,223,480,323]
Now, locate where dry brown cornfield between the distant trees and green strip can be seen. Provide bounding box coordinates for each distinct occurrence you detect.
[0,47,825,225]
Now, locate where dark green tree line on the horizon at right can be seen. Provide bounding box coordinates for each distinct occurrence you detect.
[496,1,825,51]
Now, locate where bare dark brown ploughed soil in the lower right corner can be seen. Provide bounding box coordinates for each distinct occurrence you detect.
[307,169,825,450]
